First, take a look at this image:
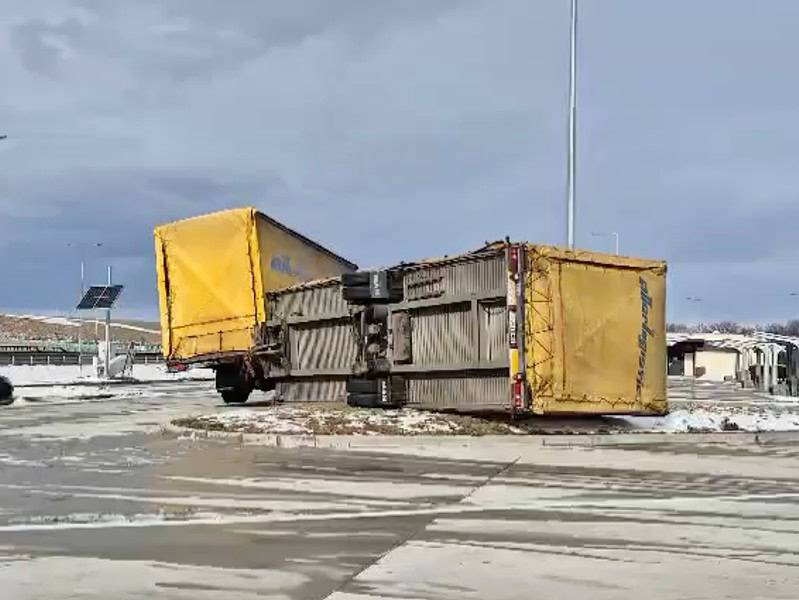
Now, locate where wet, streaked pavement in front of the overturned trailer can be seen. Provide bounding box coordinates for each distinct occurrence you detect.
[0,383,799,600]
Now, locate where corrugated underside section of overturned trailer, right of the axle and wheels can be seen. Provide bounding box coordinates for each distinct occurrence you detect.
[389,248,511,410]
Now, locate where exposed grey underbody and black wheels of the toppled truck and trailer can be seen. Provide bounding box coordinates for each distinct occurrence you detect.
[195,243,511,409]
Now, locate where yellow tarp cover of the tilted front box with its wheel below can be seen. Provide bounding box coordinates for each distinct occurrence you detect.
[155,208,357,360]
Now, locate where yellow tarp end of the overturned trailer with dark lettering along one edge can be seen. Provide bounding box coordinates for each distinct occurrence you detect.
[525,245,667,414]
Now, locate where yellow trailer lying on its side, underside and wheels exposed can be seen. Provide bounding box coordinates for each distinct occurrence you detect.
[253,242,667,415]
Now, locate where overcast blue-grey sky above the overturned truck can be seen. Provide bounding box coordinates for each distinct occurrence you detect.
[0,0,799,322]
